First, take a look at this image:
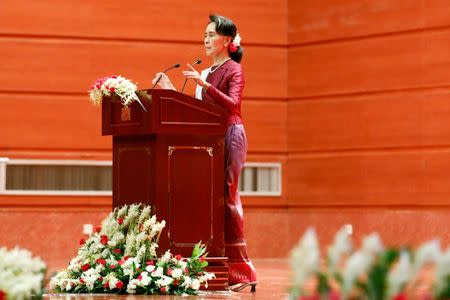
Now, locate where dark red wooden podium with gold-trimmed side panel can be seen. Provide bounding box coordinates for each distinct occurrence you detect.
[102,89,228,290]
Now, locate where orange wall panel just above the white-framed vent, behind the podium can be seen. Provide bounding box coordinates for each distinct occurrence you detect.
[0,93,287,153]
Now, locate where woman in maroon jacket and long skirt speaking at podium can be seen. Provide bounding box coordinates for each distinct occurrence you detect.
[153,15,257,292]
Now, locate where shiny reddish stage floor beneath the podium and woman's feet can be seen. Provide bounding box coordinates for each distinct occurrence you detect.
[44,259,290,300]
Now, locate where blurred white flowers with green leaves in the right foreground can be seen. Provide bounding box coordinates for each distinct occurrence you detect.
[289,227,450,300]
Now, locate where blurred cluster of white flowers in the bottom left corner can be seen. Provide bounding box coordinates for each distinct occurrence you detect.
[0,247,47,299]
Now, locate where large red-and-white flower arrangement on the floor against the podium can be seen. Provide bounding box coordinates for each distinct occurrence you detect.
[50,204,214,295]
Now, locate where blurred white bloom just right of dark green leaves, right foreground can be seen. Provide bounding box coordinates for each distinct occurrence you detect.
[388,251,413,299]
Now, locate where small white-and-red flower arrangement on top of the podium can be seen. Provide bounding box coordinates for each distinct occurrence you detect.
[89,75,142,106]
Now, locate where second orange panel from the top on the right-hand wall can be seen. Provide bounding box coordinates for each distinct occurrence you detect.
[288,30,450,98]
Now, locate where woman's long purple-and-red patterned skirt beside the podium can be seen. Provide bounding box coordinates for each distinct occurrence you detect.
[225,124,256,285]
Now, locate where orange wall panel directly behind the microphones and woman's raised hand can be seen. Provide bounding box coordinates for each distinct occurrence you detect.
[0,38,287,98]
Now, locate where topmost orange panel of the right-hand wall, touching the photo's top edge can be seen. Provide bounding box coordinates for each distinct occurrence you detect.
[288,0,450,45]
